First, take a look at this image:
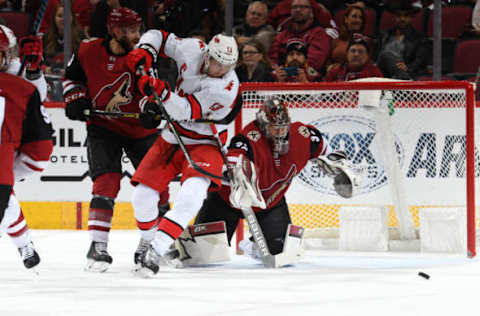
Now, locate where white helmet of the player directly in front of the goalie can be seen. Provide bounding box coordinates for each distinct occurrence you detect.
[207,34,238,68]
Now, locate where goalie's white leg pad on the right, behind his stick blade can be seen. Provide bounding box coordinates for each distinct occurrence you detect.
[239,224,304,268]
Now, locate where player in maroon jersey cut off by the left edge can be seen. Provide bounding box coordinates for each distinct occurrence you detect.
[0,28,53,269]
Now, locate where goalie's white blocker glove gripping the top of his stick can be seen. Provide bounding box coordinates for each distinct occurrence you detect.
[230,155,266,209]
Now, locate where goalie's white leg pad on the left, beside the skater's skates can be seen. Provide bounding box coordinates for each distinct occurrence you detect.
[175,221,231,265]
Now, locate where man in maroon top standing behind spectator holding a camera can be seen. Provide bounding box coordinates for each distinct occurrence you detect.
[269,0,331,73]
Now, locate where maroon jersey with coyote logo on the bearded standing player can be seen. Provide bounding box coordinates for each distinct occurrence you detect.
[63,38,157,138]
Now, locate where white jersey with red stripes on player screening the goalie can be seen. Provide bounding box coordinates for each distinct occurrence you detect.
[138,30,239,145]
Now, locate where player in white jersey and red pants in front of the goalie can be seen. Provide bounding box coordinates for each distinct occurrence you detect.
[127,30,239,275]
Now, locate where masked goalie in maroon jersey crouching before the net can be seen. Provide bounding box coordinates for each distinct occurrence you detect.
[191,98,360,259]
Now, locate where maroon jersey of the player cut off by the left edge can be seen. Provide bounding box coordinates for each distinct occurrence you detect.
[0,72,53,186]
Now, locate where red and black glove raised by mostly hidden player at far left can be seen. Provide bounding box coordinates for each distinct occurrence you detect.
[18,35,43,80]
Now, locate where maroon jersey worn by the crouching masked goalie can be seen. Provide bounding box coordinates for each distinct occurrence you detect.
[218,121,327,212]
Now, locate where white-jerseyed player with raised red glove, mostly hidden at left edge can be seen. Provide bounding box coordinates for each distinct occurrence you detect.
[0,24,47,102]
